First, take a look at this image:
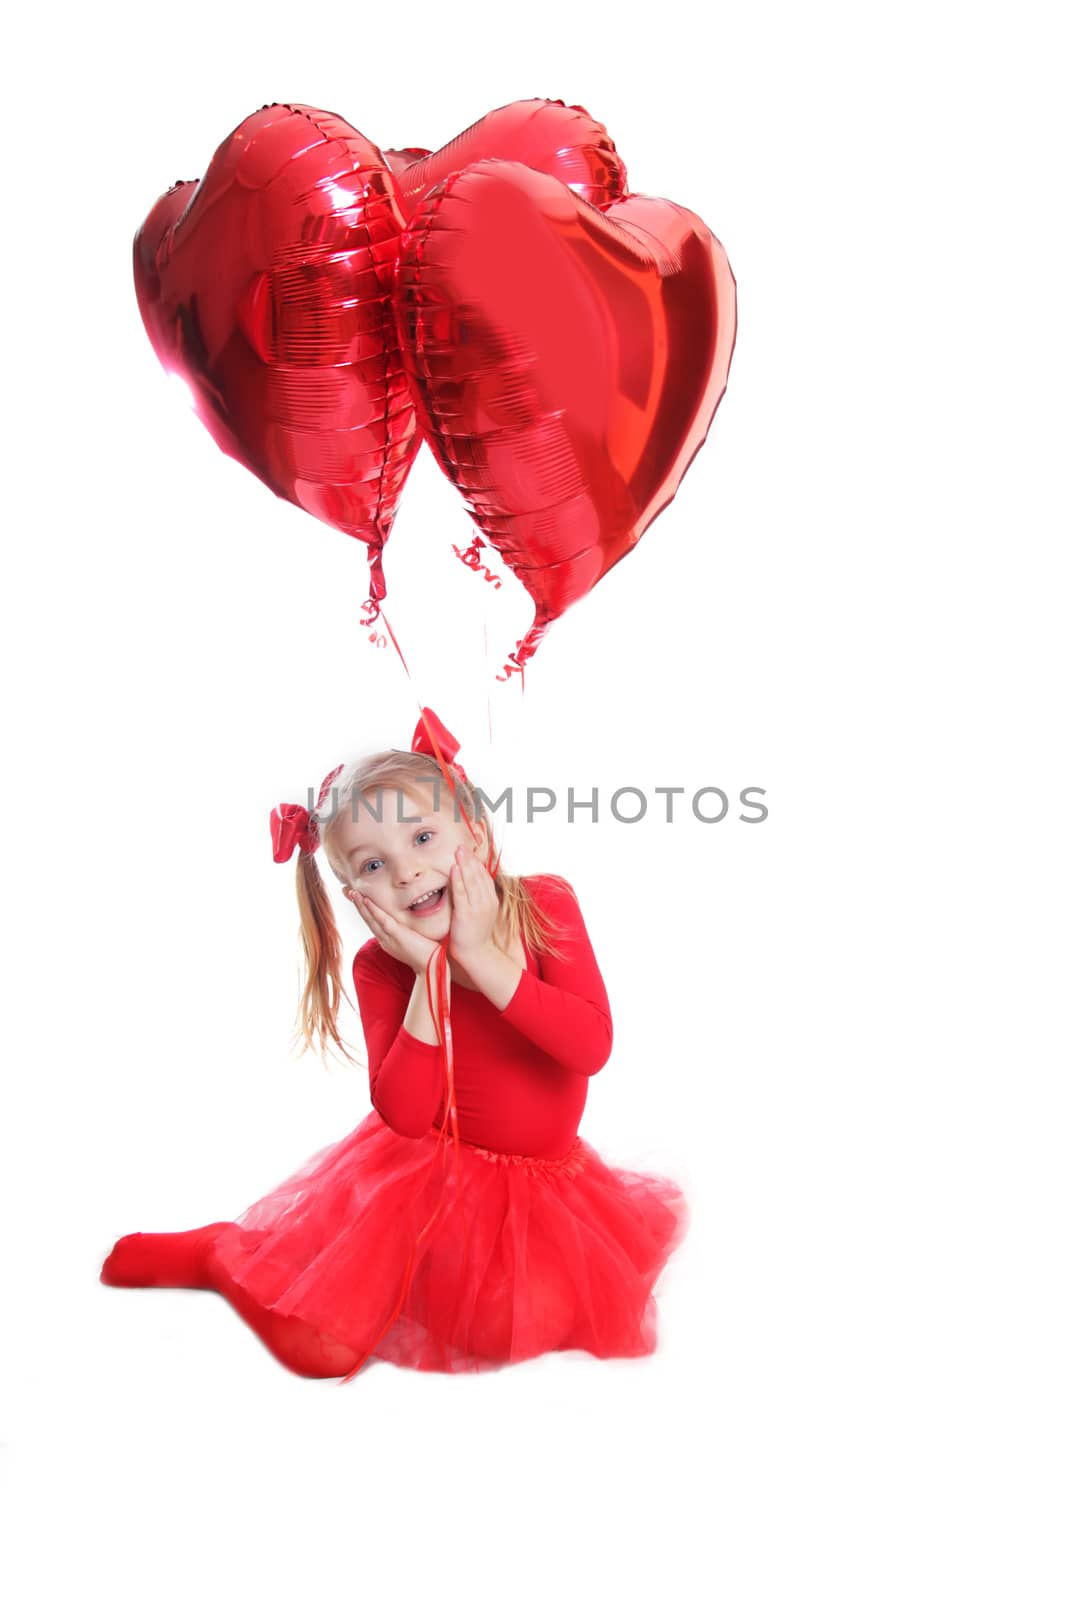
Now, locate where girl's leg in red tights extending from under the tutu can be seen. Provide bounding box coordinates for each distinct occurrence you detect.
[101,1222,358,1378]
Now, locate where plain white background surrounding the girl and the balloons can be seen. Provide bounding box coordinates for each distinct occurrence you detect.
[0,0,1067,1600]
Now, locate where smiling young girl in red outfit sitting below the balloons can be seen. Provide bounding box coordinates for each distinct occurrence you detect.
[101,707,688,1378]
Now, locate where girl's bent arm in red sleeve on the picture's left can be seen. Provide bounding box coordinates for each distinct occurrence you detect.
[352,941,451,1139]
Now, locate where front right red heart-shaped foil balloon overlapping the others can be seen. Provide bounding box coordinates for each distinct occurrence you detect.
[394,160,736,675]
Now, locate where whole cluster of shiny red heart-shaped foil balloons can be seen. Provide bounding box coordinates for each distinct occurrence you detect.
[133,99,736,675]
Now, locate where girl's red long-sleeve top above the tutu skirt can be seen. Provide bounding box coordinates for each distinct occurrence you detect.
[352,875,613,1158]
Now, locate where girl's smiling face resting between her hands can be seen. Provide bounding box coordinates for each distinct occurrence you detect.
[330,779,488,939]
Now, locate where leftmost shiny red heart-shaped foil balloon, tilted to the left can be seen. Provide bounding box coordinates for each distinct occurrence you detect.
[133,106,419,616]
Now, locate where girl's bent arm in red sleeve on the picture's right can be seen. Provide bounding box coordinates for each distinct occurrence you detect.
[467,878,613,1077]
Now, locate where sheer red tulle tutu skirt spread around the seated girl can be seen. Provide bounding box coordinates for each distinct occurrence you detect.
[214,1110,689,1378]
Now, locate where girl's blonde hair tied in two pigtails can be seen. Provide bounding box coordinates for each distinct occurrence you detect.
[294,750,569,1066]
